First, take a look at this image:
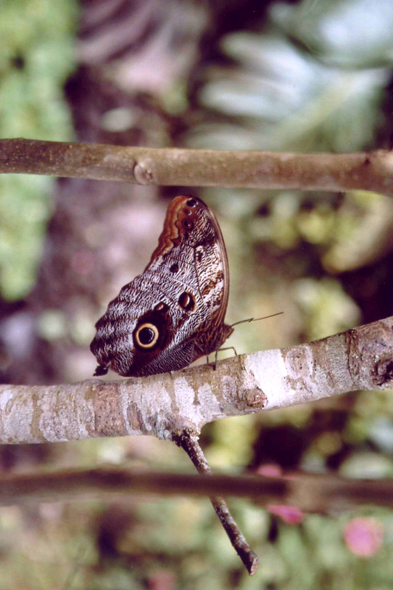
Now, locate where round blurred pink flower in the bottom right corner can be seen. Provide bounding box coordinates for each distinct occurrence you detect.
[344,517,383,557]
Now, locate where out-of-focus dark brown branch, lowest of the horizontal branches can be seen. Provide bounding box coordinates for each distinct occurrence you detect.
[0,467,393,513]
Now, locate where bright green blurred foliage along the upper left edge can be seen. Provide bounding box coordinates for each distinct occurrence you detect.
[0,0,79,299]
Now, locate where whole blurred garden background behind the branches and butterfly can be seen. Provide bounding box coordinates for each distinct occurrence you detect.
[0,0,393,590]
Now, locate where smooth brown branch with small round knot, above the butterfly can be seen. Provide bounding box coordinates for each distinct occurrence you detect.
[0,139,393,196]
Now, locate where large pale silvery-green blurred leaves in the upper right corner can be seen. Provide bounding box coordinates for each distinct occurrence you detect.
[188,0,393,152]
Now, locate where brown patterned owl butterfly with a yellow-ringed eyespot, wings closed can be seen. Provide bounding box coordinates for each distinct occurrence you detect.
[90,196,233,377]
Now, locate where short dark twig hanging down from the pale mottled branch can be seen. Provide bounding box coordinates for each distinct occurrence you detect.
[173,430,259,576]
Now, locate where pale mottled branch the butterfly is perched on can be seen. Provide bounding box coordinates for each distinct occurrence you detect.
[0,317,393,444]
